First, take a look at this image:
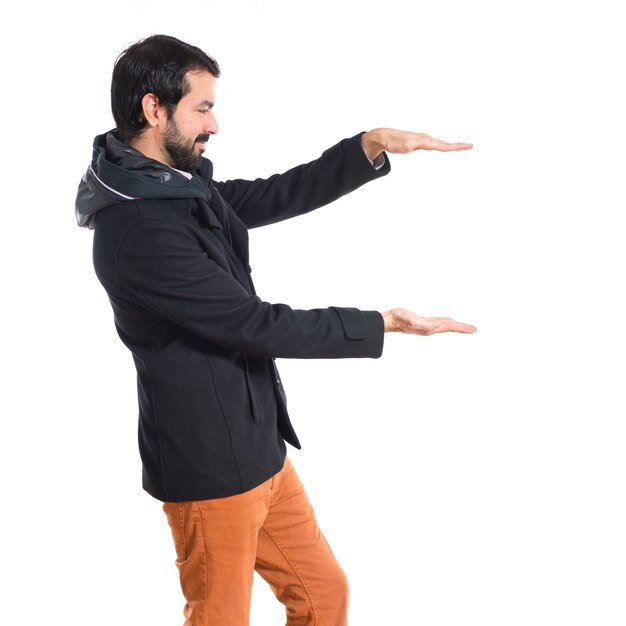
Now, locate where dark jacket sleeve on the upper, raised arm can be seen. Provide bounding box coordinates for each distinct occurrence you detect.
[215,133,391,228]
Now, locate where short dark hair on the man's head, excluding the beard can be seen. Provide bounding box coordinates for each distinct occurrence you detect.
[111,35,220,143]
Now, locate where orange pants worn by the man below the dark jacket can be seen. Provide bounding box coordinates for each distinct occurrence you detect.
[163,459,348,626]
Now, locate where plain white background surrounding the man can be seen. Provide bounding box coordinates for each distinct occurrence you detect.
[0,0,626,626]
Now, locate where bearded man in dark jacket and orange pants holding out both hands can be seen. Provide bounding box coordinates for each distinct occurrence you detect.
[76,35,476,626]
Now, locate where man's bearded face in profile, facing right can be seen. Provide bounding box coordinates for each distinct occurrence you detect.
[162,71,217,172]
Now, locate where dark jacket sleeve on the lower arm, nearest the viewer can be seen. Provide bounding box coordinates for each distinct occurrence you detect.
[117,218,384,358]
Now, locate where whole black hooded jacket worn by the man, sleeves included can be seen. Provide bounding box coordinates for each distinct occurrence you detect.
[76,131,389,501]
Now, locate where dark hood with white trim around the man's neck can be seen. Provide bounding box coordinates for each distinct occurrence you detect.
[76,130,213,228]
